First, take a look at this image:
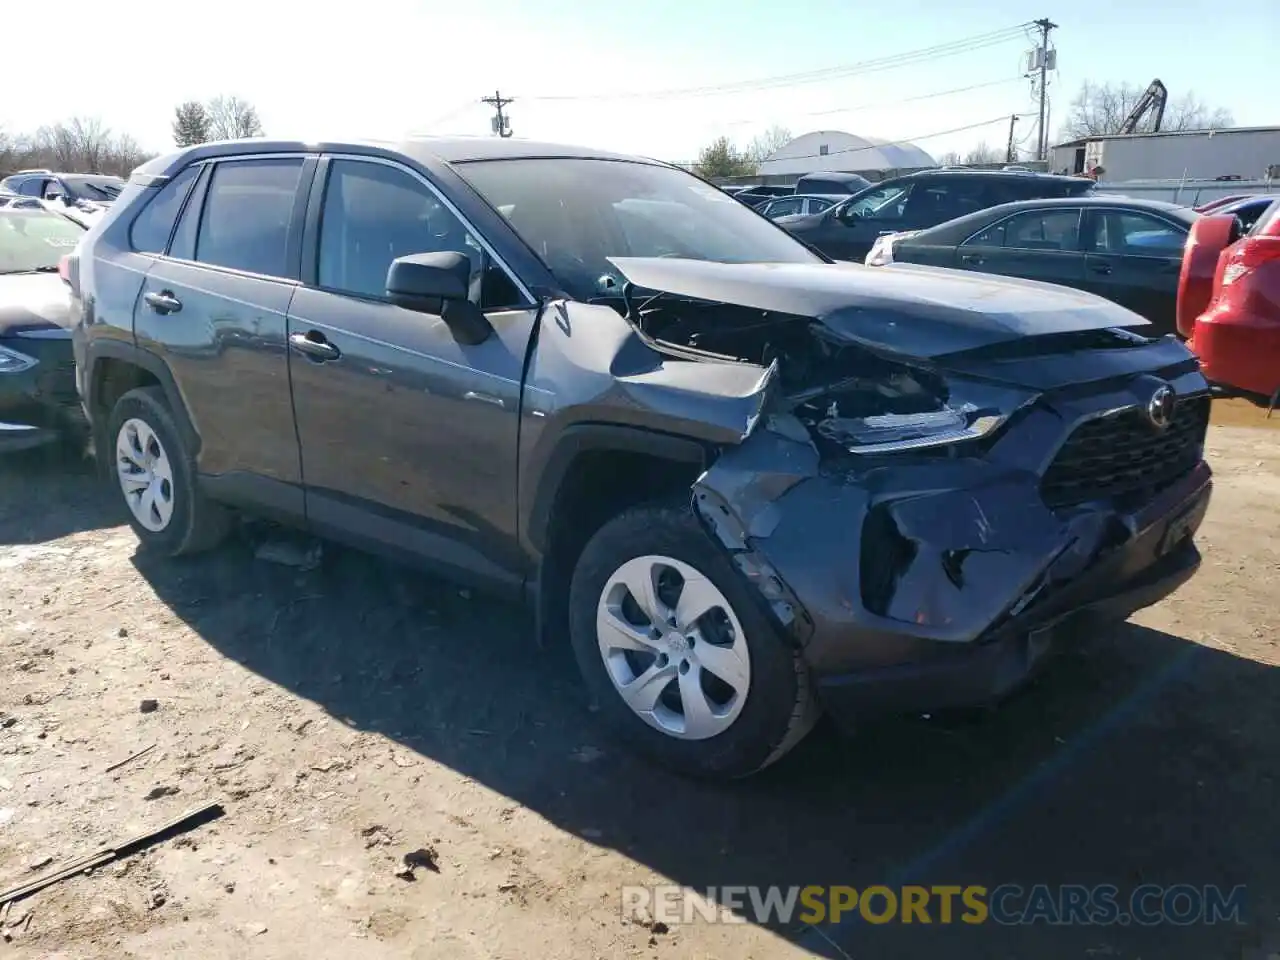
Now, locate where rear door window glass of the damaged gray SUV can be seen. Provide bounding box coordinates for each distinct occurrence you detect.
[196,157,302,276]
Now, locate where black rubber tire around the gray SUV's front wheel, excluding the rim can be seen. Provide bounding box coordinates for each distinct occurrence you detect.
[570,503,818,780]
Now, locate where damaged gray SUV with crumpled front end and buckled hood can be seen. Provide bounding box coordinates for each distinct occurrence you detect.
[68,138,1211,777]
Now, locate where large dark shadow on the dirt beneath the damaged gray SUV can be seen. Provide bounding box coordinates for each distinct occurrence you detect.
[134,541,1280,960]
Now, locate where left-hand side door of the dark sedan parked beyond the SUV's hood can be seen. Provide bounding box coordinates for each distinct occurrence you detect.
[955,206,1085,289]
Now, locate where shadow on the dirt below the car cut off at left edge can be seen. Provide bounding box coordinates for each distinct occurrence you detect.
[0,445,127,545]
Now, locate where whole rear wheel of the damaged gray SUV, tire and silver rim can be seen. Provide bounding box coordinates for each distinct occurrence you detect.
[109,387,229,557]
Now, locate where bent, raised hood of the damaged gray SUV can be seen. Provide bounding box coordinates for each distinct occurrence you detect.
[609,257,1147,357]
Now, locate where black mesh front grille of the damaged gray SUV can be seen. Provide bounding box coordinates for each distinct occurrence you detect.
[1041,397,1210,507]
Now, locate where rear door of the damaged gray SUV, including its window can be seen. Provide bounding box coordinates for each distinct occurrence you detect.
[134,155,316,516]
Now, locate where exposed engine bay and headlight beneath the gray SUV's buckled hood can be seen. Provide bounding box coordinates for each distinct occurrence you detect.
[619,294,978,454]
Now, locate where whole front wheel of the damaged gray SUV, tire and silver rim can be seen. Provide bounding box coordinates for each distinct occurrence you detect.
[570,504,817,778]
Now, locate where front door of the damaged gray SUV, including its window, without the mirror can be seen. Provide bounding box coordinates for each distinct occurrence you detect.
[289,157,536,585]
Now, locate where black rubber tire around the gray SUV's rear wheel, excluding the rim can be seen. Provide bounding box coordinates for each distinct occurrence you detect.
[106,387,230,557]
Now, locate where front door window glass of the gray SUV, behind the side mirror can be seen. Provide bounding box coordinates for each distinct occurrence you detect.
[317,160,521,308]
